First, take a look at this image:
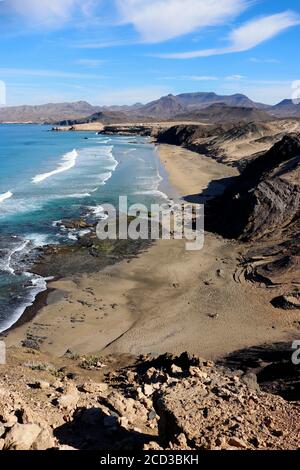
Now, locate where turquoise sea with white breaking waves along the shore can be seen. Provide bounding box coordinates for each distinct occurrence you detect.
[0,125,171,331]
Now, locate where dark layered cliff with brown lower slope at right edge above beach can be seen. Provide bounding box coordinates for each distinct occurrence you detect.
[210,134,300,308]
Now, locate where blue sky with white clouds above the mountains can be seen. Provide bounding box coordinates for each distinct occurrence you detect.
[0,0,300,105]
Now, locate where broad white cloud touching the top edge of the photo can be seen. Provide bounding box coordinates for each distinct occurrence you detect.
[116,0,249,43]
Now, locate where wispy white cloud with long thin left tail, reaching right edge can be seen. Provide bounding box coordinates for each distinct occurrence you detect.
[159,11,300,59]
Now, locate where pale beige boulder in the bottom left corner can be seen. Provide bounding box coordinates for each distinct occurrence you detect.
[3,423,41,450]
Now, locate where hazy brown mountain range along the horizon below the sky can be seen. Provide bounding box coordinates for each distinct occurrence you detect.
[0,92,300,124]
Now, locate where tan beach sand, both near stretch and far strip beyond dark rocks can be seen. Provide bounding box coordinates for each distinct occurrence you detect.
[6,145,296,359]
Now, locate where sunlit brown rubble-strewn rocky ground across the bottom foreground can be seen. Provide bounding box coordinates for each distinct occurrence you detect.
[0,350,300,451]
